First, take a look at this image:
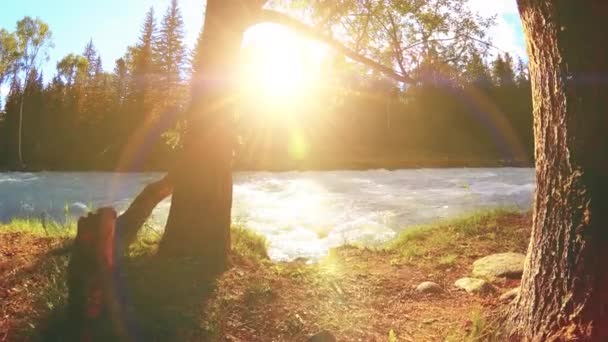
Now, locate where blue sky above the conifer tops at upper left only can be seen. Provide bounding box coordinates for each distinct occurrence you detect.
[0,0,204,80]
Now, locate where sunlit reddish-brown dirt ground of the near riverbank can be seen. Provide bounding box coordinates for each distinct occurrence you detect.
[0,214,530,341]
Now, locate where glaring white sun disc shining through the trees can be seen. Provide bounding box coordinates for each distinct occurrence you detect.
[241,24,326,107]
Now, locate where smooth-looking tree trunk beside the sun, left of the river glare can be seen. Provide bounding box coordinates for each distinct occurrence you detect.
[159,0,261,271]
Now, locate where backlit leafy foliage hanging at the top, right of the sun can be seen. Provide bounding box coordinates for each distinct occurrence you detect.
[273,0,495,76]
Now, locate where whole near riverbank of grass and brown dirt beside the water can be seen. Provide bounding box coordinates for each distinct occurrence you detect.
[0,211,530,341]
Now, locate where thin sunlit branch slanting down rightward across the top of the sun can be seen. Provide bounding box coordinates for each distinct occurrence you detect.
[251,9,414,83]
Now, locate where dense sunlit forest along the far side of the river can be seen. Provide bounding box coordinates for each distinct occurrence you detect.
[0,0,533,170]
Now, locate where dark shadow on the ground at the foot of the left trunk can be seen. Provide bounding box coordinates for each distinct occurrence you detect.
[35,255,221,341]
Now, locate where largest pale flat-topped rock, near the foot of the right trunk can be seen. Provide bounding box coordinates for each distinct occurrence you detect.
[473,253,526,278]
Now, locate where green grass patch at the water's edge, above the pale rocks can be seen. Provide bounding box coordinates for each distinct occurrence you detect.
[386,208,528,268]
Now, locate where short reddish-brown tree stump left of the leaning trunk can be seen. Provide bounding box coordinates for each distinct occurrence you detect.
[67,208,116,341]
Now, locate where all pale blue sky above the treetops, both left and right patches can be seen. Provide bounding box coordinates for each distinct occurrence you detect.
[0,0,525,96]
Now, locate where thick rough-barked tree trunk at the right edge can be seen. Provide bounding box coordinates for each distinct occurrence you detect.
[511,0,608,341]
